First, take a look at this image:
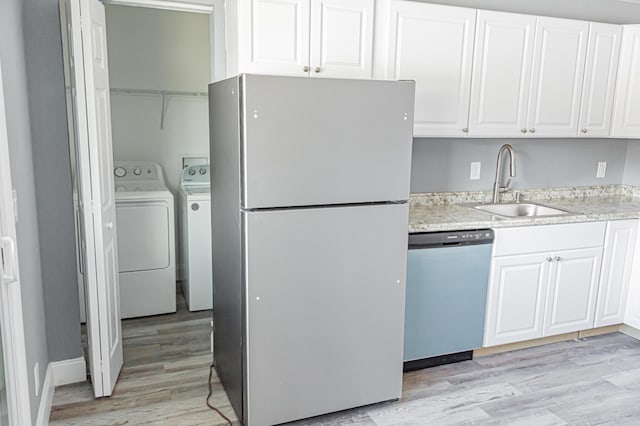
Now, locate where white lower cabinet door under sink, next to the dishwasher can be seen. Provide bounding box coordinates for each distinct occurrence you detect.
[484,254,549,346]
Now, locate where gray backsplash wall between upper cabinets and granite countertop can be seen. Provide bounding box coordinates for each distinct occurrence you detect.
[411,138,640,192]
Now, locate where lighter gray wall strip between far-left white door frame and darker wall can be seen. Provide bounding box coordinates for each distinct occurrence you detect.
[0,0,50,421]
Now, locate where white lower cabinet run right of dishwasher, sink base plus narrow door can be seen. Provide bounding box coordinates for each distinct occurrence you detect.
[484,220,637,346]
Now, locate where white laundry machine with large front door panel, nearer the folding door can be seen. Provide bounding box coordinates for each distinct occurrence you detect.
[114,161,176,318]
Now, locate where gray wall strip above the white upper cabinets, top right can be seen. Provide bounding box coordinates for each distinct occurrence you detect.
[418,0,640,24]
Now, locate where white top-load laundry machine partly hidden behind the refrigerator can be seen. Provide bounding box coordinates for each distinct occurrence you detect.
[178,165,213,311]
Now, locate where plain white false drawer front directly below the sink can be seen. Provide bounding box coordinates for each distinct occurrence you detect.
[493,222,606,256]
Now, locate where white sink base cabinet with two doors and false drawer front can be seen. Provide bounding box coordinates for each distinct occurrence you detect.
[484,222,606,346]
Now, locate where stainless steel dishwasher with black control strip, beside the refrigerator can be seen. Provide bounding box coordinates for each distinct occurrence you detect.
[404,229,494,371]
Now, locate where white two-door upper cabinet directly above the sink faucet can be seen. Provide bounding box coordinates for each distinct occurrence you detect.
[469,11,589,137]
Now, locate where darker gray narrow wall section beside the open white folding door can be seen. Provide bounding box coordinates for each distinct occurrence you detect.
[23,0,82,361]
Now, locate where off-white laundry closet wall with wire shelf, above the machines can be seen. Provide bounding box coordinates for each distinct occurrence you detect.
[107,5,210,193]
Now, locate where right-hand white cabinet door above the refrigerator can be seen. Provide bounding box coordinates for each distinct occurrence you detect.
[310,0,373,78]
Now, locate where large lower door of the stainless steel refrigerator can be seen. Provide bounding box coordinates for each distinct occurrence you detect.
[243,204,408,426]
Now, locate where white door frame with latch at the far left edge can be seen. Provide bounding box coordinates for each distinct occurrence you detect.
[0,57,31,426]
